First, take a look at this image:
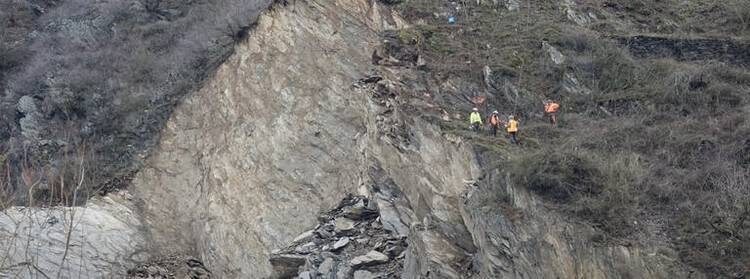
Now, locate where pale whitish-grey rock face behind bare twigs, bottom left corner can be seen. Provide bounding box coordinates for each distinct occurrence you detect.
[0,193,149,278]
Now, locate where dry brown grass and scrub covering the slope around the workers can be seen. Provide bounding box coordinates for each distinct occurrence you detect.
[403,1,750,276]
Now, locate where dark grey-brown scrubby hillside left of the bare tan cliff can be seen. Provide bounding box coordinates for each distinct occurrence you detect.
[0,0,272,208]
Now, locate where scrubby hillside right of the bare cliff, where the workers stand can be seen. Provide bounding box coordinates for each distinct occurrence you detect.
[394,0,750,277]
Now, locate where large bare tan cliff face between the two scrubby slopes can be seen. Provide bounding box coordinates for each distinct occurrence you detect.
[134,1,408,277]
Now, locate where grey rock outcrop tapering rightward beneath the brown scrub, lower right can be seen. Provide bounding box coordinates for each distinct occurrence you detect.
[462,163,704,278]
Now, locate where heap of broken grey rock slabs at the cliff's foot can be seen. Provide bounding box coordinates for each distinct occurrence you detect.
[270,195,408,279]
